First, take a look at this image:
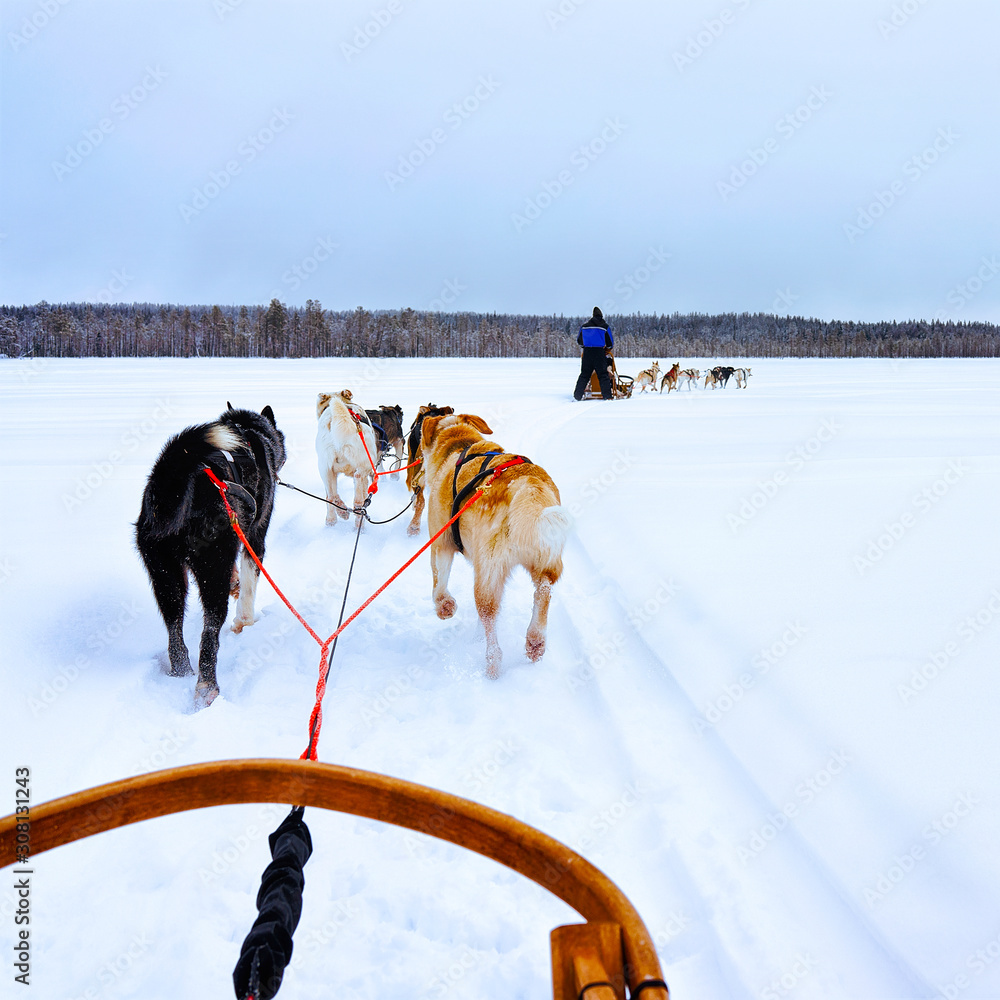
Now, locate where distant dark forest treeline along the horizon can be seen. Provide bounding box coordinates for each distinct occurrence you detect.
[0,299,1000,360]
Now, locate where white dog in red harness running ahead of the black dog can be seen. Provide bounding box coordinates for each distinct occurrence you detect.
[316,389,378,527]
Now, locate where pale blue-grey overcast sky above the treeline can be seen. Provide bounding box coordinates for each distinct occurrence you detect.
[0,0,1000,322]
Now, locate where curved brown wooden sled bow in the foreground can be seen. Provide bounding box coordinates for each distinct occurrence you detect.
[0,759,668,1000]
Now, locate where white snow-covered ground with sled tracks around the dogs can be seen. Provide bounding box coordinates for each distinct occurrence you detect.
[0,359,1000,1000]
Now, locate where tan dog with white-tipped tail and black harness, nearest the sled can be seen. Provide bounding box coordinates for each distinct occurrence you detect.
[421,413,571,678]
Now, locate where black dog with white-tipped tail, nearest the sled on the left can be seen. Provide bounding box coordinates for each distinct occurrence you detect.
[135,404,285,707]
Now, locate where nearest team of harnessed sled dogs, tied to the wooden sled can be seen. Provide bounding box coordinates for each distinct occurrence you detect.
[135,389,571,707]
